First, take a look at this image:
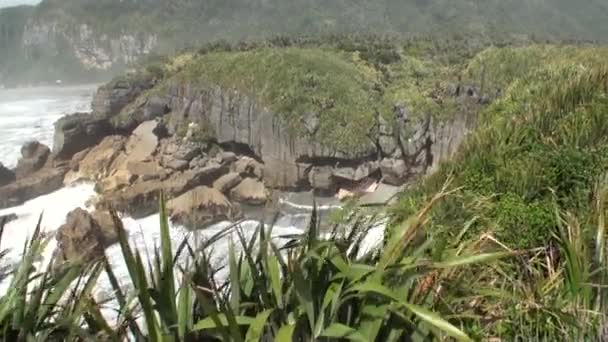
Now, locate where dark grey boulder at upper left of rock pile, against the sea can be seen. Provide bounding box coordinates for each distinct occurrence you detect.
[53,113,113,160]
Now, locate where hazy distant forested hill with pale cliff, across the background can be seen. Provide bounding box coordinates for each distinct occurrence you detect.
[0,0,608,83]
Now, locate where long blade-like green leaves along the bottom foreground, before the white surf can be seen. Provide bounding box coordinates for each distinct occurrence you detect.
[0,188,514,341]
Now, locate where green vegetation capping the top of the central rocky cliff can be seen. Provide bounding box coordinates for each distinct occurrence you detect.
[113,36,476,155]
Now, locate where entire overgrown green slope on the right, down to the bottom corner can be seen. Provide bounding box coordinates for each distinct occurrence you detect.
[393,44,608,341]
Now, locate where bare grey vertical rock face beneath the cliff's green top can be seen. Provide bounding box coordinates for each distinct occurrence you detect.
[134,81,479,189]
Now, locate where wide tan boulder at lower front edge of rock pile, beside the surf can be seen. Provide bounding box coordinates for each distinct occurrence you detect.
[167,186,242,228]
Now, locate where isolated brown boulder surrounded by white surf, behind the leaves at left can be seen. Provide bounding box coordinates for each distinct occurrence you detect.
[56,208,118,262]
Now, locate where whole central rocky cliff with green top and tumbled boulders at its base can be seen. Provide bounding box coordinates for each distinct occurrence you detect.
[0,43,490,226]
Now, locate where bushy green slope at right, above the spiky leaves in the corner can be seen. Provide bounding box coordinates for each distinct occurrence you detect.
[395,47,608,248]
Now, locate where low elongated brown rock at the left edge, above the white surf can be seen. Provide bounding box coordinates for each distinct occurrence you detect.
[0,166,69,208]
